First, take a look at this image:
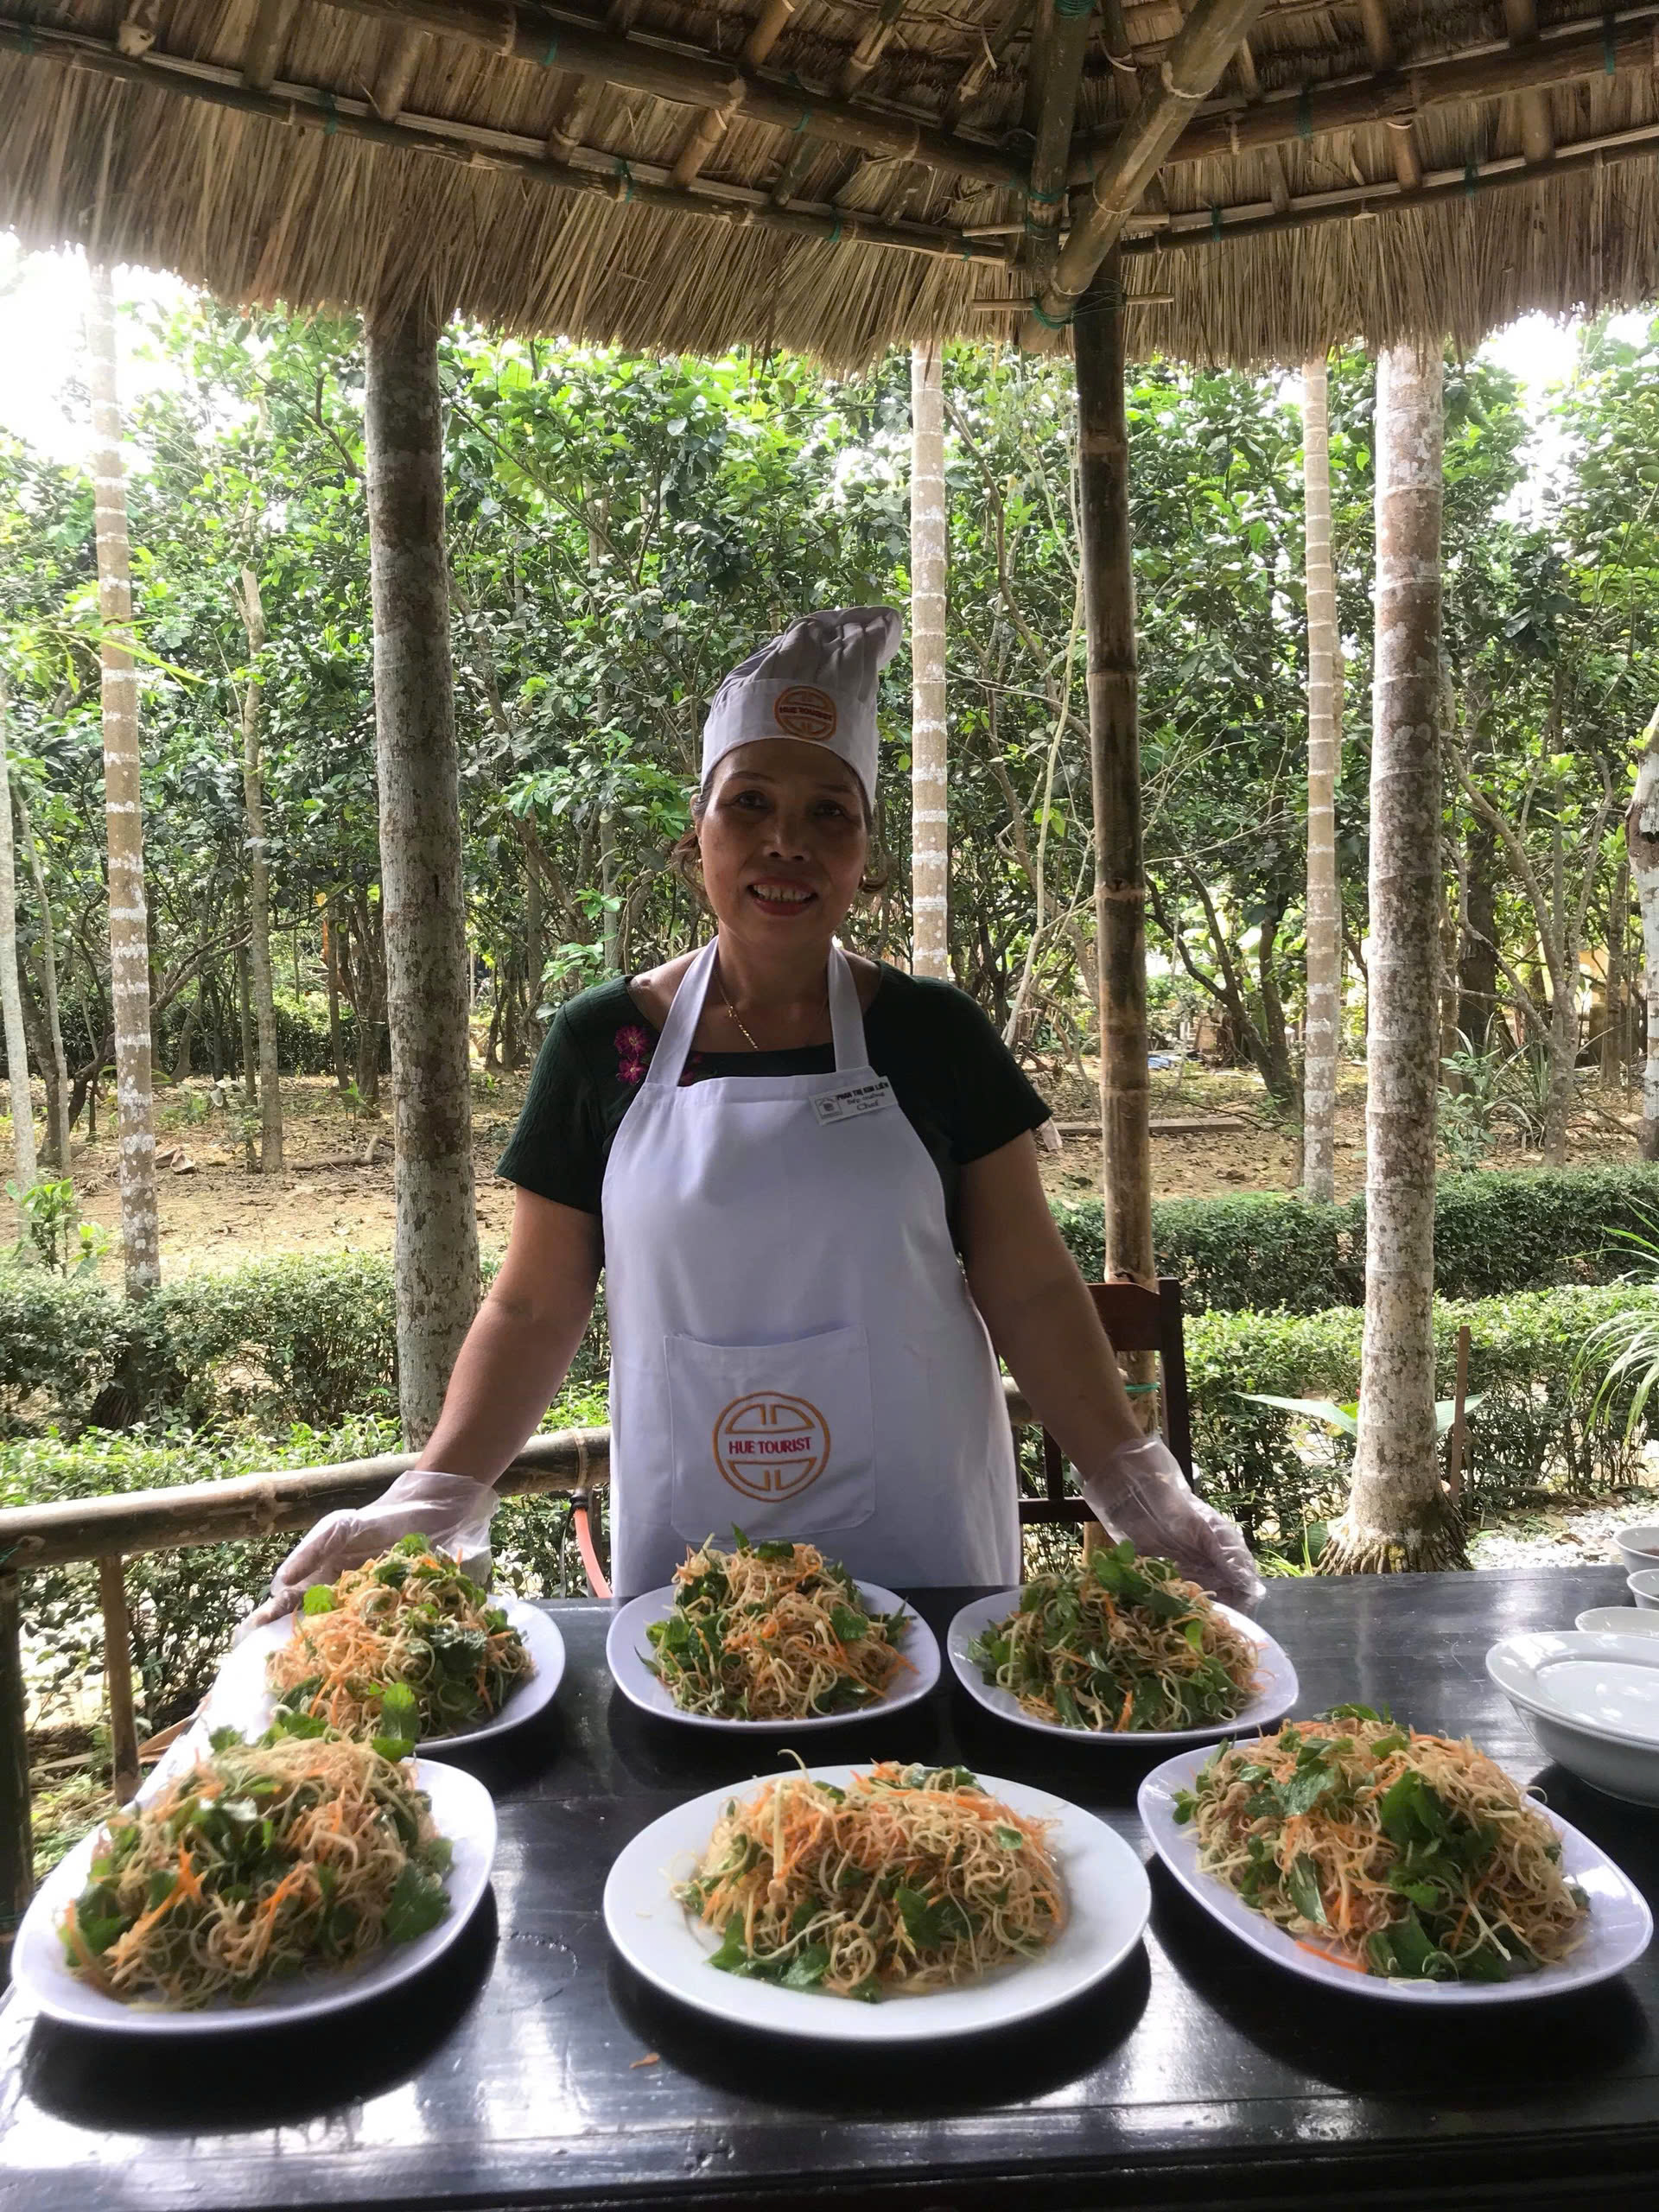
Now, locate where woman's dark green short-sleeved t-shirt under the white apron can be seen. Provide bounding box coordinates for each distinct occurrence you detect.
[495,964,1048,1234]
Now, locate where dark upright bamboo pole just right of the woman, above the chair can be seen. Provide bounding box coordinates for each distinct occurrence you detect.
[1073,252,1154,1283]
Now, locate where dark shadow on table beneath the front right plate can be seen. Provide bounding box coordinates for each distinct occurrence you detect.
[1148,1860,1648,2106]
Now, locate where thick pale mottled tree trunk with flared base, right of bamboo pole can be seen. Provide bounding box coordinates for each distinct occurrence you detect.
[1320,345,1465,1575]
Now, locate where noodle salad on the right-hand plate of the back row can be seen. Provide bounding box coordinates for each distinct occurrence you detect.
[969,1544,1256,1734]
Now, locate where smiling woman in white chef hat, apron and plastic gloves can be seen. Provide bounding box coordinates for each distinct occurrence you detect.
[250,606,1256,1617]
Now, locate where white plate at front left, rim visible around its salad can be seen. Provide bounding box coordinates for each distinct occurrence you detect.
[11,1758,495,2035]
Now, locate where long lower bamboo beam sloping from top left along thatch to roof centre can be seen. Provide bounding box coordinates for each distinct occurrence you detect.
[0,16,1011,268]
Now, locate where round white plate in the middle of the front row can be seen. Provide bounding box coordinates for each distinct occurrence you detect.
[604,1765,1153,2044]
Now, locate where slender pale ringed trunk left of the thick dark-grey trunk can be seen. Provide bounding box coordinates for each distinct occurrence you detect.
[86,264,162,1299]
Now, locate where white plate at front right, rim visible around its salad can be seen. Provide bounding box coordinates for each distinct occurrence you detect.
[1137,1750,1652,2004]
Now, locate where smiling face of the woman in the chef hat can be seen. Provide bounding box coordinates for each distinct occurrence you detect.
[696,736,869,944]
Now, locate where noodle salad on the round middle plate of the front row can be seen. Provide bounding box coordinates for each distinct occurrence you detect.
[675,1761,1066,2002]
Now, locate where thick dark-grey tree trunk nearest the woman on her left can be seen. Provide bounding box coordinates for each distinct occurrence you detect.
[365,309,478,1449]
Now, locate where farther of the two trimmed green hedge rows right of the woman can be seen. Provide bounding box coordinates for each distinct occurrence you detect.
[1055,1166,1659,1314]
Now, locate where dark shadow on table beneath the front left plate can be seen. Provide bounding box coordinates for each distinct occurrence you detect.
[22,1891,498,2137]
